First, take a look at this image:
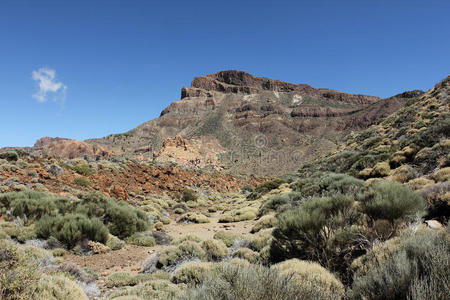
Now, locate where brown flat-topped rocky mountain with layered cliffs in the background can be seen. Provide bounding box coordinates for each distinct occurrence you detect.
[88,71,421,175]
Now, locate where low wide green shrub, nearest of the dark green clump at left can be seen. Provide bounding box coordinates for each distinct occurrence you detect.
[36,214,108,248]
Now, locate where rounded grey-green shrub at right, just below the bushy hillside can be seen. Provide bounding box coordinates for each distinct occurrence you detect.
[359,181,426,222]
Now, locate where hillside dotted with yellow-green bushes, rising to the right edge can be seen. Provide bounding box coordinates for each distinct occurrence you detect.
[300,76,450,221]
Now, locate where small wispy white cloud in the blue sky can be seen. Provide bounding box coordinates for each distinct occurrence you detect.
[31,68,67,103]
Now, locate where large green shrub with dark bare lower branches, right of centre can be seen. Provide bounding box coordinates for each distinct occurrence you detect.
[270,194,361,271]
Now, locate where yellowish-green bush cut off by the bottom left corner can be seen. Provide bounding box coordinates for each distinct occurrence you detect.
[0,240,39,300]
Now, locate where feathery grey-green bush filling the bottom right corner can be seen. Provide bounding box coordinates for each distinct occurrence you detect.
[348,230,450,299]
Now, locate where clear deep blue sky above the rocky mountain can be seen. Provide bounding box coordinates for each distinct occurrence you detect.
[0,0,450,147]
